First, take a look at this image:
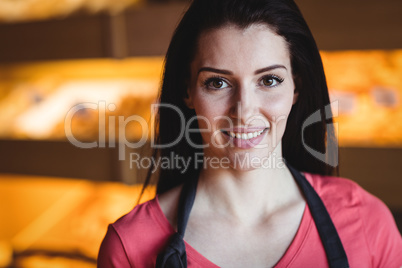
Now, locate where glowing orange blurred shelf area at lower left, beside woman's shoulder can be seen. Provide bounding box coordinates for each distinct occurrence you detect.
[0,175,155,267]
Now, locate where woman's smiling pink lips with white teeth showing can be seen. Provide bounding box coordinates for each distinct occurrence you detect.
[222,127,269,149]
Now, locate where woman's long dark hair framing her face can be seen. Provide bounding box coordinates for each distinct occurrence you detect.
[138,0,335,197]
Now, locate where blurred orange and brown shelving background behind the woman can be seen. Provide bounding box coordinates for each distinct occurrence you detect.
[0,0,402,267]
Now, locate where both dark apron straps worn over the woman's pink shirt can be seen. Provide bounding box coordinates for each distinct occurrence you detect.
[155,165,349,268]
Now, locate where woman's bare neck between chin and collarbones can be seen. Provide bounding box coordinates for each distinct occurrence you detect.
[197,149,301,224]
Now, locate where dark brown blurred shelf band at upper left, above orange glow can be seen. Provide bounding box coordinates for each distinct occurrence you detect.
[0,2,187,63]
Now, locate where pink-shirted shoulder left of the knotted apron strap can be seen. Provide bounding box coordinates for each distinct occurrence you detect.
[98,197,174,267]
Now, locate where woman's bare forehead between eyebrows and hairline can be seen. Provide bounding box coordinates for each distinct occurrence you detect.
[193,24,290,69]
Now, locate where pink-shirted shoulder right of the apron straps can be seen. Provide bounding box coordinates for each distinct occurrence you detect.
[305,173,402,267]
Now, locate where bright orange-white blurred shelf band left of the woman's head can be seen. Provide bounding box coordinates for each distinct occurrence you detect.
[0,57,163,141]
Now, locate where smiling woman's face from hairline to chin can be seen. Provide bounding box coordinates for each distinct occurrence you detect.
[185,24,297,169]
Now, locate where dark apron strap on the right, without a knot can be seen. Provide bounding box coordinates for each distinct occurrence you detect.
[287,164,349,268]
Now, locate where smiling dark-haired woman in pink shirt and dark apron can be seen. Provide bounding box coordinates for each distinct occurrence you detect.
[98,0,402,267]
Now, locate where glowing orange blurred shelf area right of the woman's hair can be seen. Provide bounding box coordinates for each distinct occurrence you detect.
[322,50,402,147]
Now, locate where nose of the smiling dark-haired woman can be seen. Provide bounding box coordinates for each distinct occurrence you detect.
[230,86,259,125]
